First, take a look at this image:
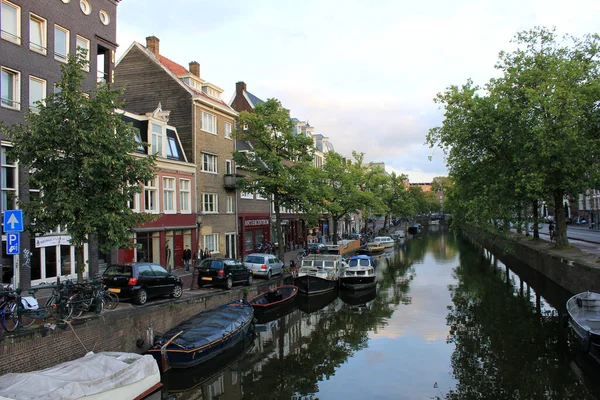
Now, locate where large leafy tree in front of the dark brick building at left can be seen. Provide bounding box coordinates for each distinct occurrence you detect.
[1,53,154,279]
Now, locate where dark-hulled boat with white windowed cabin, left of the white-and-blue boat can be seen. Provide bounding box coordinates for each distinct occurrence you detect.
[294,254,347,294]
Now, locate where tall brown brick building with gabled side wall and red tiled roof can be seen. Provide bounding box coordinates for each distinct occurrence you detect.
[114,36,238,257]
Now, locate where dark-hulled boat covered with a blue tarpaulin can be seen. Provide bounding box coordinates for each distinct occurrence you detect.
[148,300,254,372]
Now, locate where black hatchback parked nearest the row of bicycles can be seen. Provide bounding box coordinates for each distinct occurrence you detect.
[102,263,183,305]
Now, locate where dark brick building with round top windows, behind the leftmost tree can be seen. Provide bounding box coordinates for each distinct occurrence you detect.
[0,0,118,287]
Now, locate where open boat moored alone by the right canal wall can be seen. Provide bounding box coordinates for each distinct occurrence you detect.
[567,292,600,362]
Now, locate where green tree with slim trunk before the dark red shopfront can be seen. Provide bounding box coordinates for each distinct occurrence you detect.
[233,99,314,260]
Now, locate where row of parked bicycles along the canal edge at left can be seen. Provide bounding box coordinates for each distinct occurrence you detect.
[0,277,119,332]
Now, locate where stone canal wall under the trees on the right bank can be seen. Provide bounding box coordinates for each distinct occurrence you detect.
[464,231,600,294]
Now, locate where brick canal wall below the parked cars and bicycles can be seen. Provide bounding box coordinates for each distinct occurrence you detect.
[0,277,289,375]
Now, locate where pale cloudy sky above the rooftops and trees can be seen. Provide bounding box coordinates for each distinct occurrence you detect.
[117,0,600,183]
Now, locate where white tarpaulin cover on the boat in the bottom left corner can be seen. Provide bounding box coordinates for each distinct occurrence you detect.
[0,352,160,400]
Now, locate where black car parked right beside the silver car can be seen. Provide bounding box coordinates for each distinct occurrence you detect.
[198,258,252,289]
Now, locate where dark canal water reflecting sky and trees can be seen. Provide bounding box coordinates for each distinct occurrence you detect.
[163,227,600,400]
